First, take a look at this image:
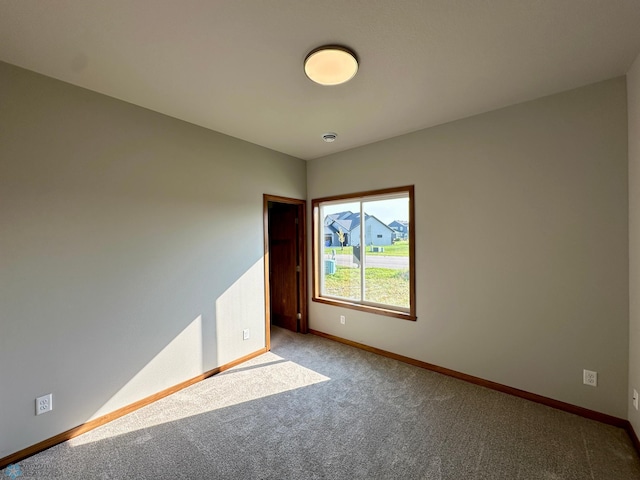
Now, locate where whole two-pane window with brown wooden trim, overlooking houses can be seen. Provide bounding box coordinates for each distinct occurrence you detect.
[312,186,416,320]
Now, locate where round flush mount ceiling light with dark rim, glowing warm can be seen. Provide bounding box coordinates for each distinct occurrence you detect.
[304,45,358,85]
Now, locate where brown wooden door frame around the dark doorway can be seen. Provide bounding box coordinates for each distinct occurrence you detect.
[262,193,309,350]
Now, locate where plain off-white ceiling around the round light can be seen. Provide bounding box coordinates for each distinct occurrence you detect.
[0,0,640,159]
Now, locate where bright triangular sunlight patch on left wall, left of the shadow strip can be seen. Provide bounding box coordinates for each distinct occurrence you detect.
[88,315,202,420]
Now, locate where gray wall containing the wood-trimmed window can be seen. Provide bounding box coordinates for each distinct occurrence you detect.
[307,78,629,418]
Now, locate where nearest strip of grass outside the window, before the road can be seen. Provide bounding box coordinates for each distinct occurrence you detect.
[324,266,409,307]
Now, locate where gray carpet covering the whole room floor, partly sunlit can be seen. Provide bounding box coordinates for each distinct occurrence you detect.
[0,328,640,480]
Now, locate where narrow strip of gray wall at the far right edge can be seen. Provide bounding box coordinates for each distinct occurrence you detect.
[627,55,640,435]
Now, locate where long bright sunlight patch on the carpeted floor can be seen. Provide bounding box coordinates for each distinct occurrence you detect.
[69,352,331,447]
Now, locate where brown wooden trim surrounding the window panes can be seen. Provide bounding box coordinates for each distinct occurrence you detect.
[311,185,417,321]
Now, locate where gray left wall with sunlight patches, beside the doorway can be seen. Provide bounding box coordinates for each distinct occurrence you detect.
[0,63,306,457]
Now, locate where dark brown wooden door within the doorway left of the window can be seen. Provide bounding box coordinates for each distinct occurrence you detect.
[269,202,300,332]
